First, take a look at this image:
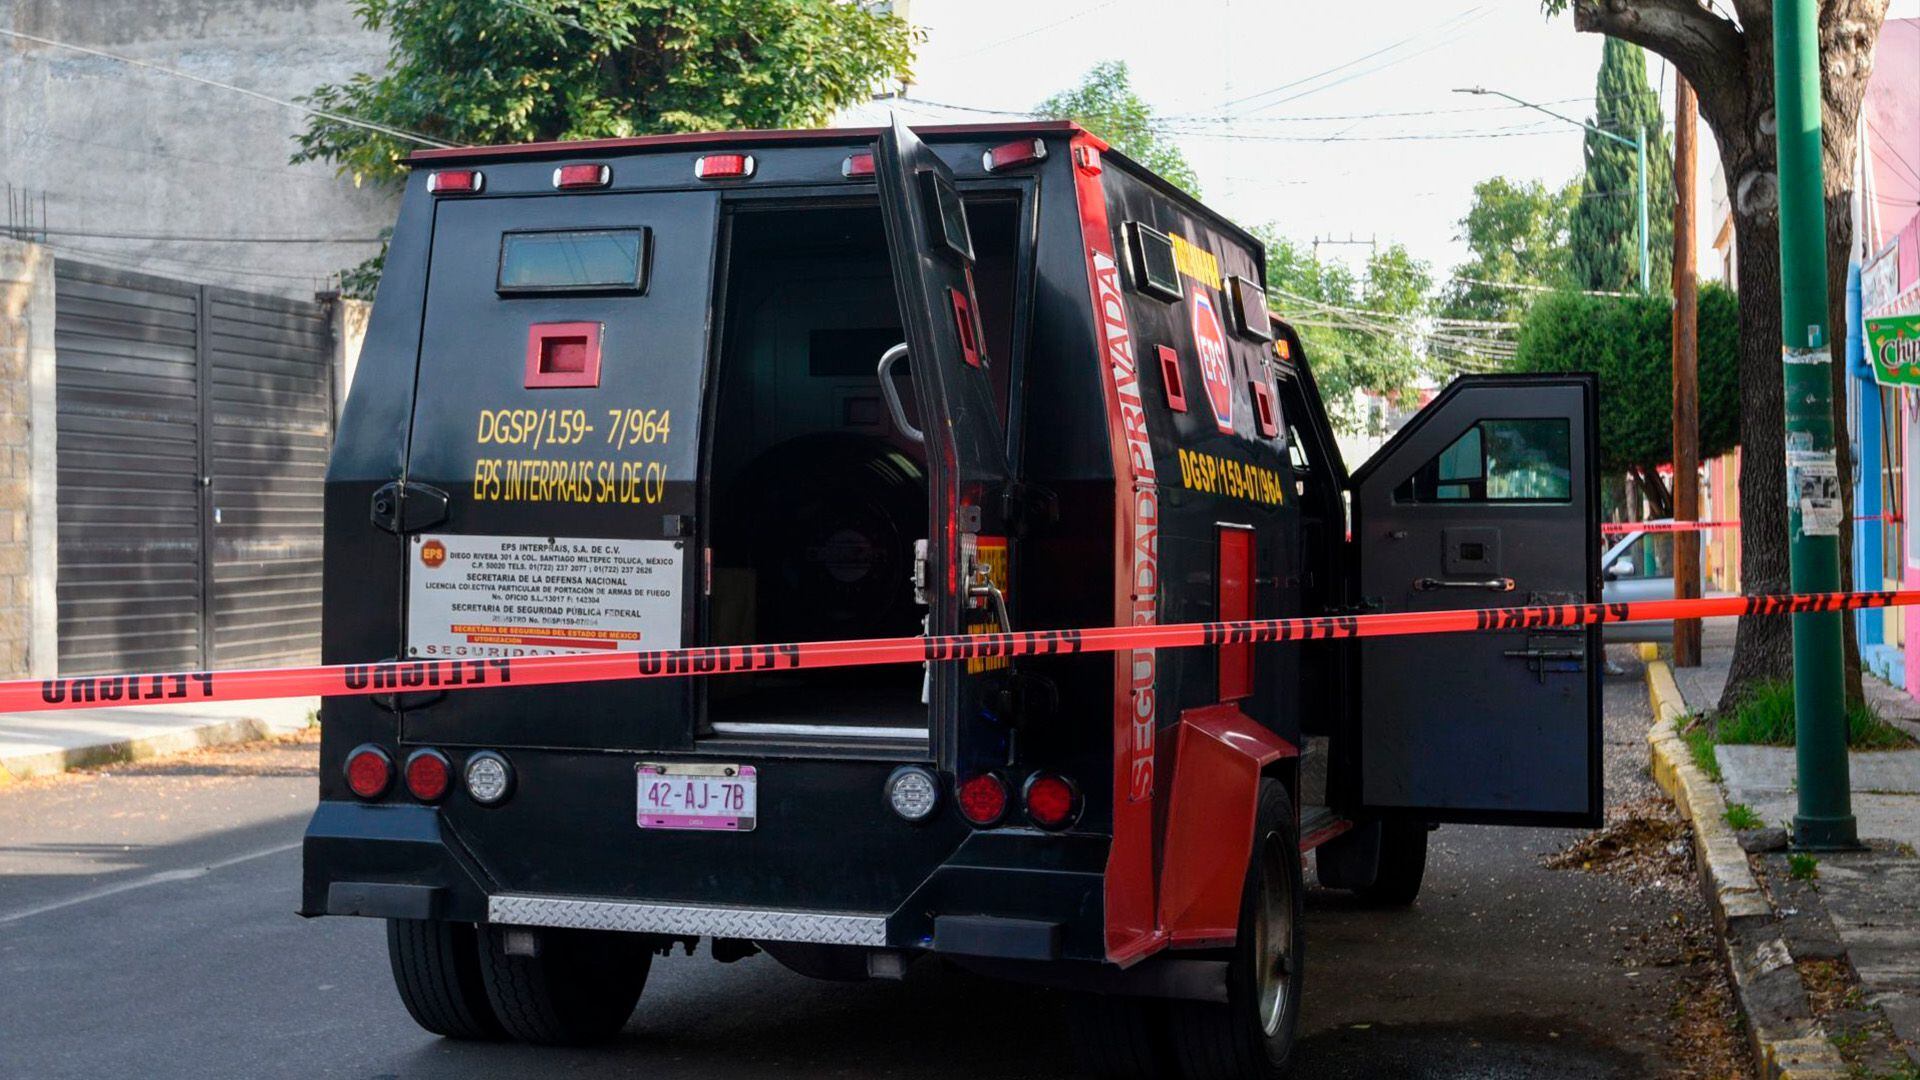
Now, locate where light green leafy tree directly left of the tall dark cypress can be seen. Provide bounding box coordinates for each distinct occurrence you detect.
[1440,177,1580,323]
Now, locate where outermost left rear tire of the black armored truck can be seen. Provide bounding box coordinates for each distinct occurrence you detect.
[386,919,507,1040]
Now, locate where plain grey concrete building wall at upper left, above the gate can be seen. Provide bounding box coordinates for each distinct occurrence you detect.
[0,0,397,298]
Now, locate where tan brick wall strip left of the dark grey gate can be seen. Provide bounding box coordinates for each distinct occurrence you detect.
[0,240,60,678]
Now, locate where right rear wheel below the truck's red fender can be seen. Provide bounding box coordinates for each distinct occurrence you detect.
[1171,780,1306,1080]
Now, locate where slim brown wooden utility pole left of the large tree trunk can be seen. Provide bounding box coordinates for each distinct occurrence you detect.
[1674,71,1699,667]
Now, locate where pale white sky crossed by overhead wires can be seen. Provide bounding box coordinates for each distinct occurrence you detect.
[848,0,1920,281]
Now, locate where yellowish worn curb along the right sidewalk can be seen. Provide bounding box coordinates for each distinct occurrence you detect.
[1642,651,1849,1080]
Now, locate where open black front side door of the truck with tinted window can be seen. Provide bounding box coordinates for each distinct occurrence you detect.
[1348,375,1603,826]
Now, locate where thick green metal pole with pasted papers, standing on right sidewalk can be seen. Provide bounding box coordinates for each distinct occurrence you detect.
[1774,0,1860,849]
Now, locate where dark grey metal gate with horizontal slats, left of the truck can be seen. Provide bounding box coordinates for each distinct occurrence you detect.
[54,259,334,675]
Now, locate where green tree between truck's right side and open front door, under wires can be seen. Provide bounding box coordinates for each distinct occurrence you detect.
[1254,225,1432,432]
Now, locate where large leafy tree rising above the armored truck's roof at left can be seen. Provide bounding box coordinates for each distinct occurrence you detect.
[294,0,918,288]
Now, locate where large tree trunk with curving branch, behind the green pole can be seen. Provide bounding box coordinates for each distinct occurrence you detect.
[1542,0,1887,707]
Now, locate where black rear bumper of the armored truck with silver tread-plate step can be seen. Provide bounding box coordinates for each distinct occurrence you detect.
[300,801,1106,961]
